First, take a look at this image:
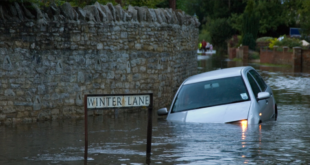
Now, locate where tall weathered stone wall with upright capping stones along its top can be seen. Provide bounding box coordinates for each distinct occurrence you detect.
[0,3,199,123]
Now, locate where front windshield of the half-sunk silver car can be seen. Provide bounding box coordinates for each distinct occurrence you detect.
[172,76,250,112]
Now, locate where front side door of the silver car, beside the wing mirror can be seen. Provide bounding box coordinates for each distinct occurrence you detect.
[247,72,267,120]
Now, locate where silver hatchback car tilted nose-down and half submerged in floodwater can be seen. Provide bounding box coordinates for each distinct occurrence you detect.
[157,66,278,124]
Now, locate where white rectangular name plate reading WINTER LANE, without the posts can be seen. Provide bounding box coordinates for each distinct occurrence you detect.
[87,95,150,109]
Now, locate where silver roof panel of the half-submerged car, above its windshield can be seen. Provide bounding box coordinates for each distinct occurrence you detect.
[183,66,253,85]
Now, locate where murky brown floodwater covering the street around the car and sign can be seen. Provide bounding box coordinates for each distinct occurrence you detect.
[0,53,310,165]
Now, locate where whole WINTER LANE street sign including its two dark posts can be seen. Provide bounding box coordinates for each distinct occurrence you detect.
[84,93,153,162]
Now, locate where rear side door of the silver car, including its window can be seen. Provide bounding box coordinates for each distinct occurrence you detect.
[249,70,274,120]
